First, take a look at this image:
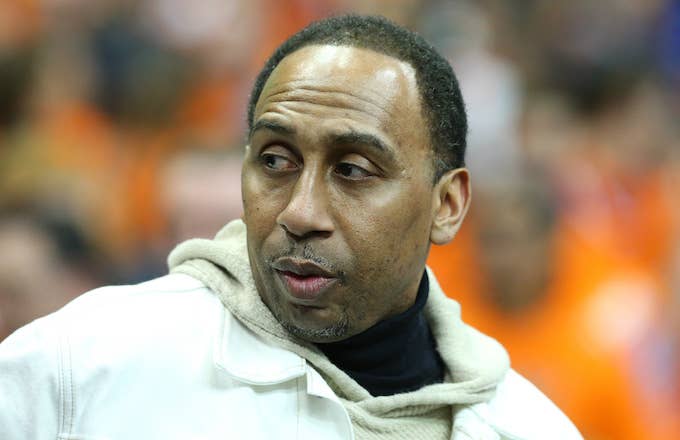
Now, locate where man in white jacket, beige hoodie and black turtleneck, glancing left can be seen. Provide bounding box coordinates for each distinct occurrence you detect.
[0,16,580,440]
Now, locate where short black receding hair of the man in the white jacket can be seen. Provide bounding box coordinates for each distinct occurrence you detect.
[248,14,467,180]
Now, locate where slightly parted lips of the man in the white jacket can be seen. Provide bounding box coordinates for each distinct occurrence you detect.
[272,257,338,301]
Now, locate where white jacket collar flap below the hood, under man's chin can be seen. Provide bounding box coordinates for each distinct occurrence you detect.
[214,310,306,385]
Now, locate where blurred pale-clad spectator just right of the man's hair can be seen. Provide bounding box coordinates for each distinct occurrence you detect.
[422,1,522,179]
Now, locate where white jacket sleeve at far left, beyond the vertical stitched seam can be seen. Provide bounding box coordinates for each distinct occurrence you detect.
[0,317,61,440]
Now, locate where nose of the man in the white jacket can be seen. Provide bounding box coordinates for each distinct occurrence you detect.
[276,169,334,239]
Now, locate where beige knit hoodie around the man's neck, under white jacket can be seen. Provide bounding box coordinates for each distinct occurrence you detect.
[168,220,509,439]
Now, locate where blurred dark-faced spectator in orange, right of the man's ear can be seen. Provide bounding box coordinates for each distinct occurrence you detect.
[429,169,659,439]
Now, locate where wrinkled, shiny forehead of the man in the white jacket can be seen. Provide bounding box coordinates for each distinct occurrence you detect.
[254,45,424,150]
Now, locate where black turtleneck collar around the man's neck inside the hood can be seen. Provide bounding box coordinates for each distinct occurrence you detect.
[317,273,445,396]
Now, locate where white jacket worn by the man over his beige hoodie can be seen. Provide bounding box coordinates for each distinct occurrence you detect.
[0,274,581,440]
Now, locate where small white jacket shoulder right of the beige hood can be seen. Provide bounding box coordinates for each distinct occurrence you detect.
[470,370,583,440]
